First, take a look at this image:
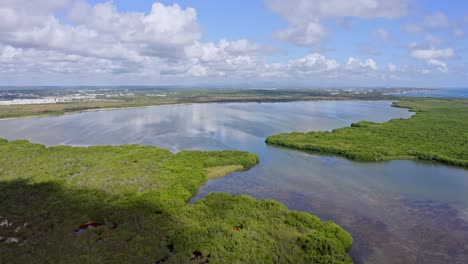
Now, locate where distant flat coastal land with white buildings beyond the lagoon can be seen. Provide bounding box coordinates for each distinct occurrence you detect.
[0,88,393,119]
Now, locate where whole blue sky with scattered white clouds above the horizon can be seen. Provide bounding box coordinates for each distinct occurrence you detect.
[0,0,468,88]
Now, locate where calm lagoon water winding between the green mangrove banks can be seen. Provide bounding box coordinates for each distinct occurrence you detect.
[0,101,468,263]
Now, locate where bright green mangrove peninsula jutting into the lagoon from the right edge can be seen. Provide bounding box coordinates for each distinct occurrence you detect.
[266,99,468,167]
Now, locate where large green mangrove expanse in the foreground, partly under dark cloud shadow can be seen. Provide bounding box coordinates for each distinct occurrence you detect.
[0,139,352,263]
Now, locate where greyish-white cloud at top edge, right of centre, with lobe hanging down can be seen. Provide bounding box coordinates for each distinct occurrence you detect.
[265,0,409,47]
